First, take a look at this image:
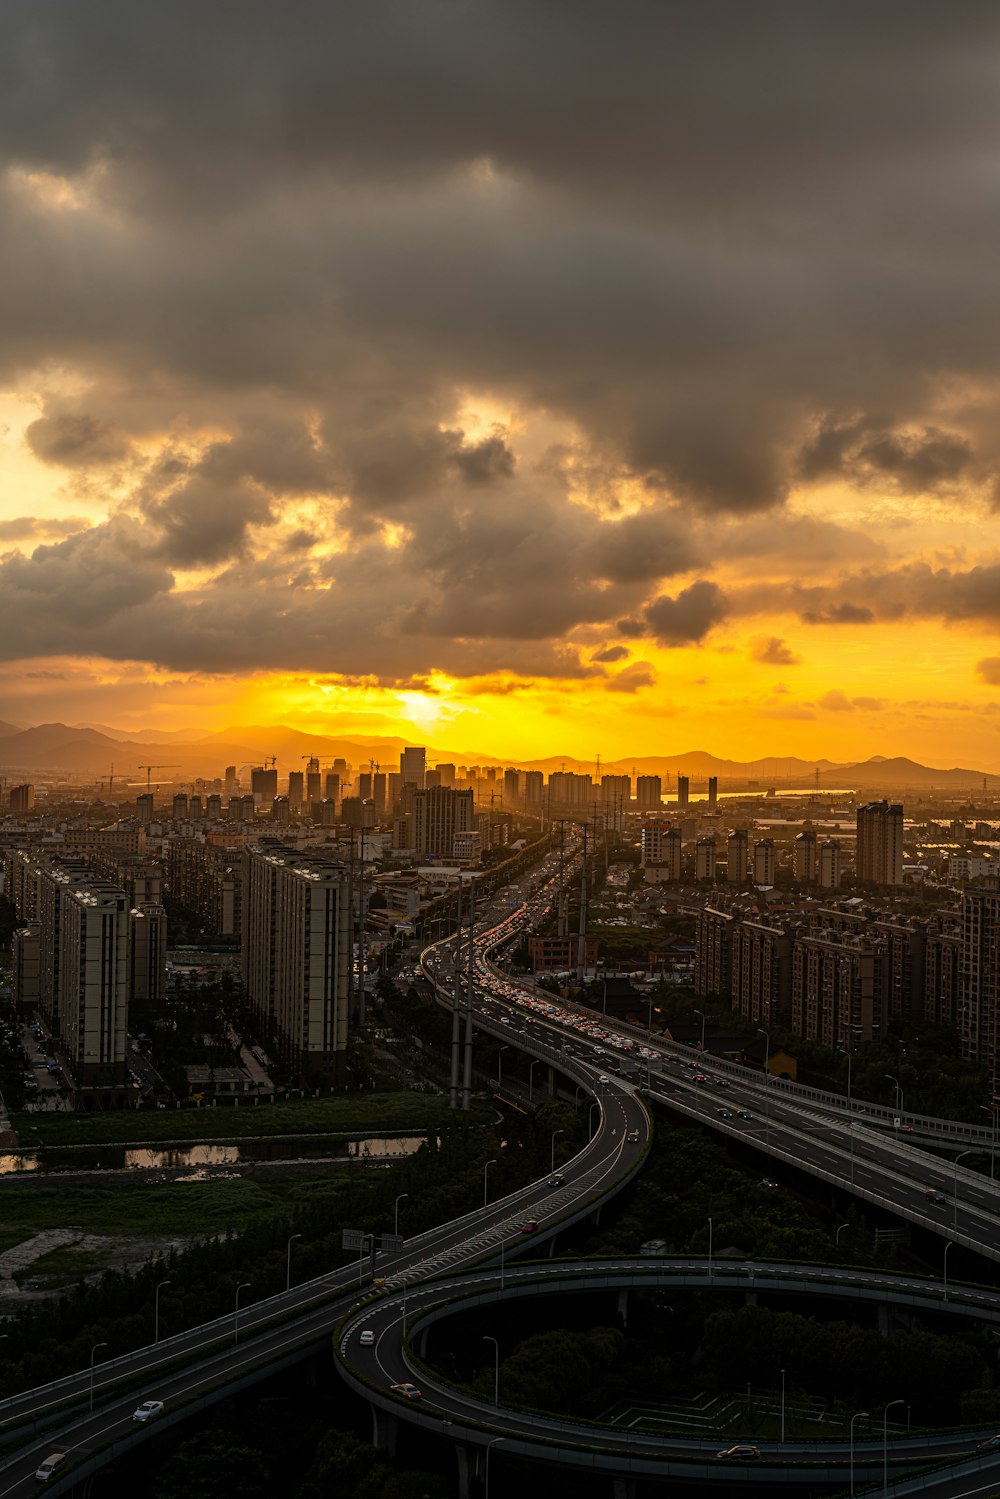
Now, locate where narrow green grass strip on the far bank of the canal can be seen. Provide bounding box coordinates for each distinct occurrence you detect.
[10,1091,493,1150]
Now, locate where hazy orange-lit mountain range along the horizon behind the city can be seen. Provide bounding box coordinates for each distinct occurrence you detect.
[0,721,1000,790]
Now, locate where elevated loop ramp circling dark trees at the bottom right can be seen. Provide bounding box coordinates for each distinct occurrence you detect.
[337,1258,1000,1495]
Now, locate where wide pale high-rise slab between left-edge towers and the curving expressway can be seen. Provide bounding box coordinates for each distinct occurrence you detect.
[241,842,352,1087]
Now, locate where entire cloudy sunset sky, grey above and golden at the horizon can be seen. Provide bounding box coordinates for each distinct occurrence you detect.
[0,0,1000,770]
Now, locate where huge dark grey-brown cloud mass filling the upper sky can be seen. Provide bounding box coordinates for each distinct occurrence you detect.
[0,0,1000,672]
